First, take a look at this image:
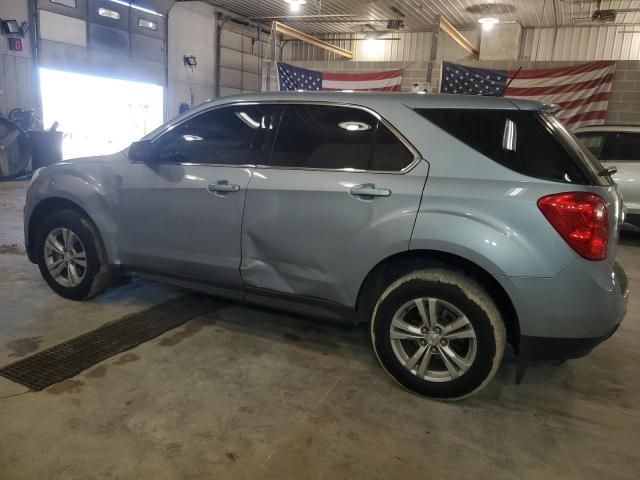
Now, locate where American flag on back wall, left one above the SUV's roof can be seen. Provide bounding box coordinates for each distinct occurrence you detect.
[278,62,402,92]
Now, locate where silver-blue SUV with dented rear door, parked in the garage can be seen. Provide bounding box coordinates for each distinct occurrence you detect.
[25,93,628,399]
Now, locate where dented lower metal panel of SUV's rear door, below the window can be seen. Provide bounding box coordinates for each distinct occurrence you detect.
[241,160,428,306]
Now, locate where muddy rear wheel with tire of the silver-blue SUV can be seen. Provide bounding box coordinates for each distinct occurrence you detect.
[371,269,506,400]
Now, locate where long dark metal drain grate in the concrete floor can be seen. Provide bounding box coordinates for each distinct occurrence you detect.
[0,295,219,390]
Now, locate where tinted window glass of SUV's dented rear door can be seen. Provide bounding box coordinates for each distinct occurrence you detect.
[270,104,413,171]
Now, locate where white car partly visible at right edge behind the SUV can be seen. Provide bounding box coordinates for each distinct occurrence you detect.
[575,125,640,227]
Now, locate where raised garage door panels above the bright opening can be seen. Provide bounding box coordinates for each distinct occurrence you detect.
[38,0,174,85]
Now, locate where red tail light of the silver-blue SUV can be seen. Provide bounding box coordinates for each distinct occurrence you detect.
[538,192,609,260]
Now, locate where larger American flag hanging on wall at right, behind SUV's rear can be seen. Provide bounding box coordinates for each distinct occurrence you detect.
[440,61,615,129]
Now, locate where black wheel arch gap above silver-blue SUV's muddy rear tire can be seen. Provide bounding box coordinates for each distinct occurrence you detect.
[356,250,520,351]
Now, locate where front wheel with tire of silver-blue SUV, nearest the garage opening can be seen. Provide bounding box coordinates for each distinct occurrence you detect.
[34,210,111,300]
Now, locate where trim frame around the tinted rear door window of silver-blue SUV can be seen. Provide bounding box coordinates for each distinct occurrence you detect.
[257,100,422,175]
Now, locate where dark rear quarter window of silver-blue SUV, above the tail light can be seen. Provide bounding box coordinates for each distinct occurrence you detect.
[417,109,588,184]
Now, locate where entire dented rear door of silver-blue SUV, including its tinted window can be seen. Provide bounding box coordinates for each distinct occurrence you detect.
[241,104,428,306]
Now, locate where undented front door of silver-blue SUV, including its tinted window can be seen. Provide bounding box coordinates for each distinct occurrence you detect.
[118,105,270,284]
